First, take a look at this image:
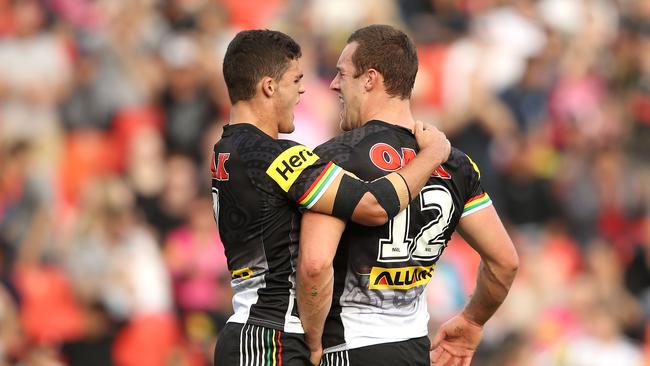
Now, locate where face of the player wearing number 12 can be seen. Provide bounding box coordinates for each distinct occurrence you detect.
[330,42,365,131]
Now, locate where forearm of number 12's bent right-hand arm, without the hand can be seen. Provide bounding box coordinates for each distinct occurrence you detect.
[463,261,517,326]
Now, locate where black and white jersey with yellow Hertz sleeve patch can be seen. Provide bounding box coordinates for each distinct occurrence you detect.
[212,124,341,333]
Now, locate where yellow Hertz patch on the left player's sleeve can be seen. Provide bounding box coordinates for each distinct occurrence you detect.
[266,145,318,192]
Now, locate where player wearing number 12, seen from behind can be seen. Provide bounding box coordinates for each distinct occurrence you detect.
[297,25,518,366]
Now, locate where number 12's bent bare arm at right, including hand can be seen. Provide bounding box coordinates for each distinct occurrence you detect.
[431,206,519,366]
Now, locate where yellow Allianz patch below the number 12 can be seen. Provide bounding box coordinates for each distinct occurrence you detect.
[368,265,436,290]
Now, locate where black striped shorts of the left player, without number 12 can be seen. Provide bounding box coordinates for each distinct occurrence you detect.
[214,323,309,366]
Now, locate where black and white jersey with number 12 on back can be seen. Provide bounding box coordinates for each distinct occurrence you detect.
[315,121,491,352]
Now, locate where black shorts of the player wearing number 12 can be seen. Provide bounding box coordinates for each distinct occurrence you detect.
[323,337,430,366]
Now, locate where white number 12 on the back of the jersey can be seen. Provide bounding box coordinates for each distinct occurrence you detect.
[377,185,454,262]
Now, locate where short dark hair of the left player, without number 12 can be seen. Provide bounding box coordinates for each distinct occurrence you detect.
[223,29,302,104]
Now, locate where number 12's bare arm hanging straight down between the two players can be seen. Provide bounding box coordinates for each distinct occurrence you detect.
[296,212,345,365]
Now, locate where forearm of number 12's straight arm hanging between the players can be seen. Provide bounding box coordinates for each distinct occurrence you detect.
[297,267,334,352]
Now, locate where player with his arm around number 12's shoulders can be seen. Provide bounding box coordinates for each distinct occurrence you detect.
[212,30,450,365]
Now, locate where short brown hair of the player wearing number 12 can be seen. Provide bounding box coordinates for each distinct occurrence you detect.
[347,24,418,99]
